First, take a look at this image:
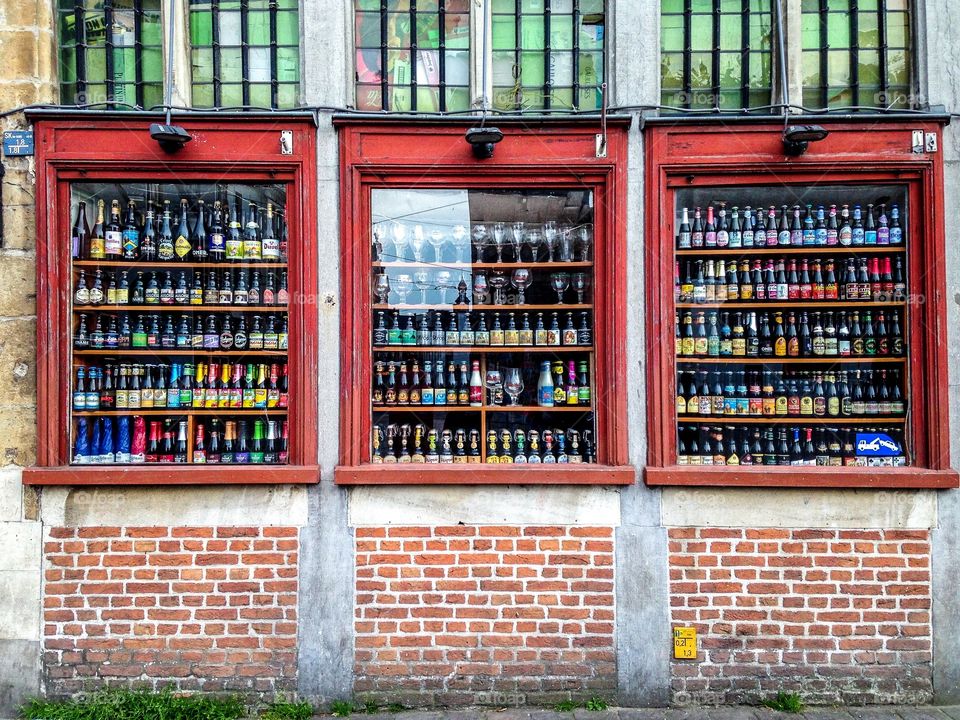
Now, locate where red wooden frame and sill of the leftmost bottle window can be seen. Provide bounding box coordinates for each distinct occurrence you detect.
[23,114,320,485]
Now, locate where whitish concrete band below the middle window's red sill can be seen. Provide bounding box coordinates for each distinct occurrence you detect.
[349,485,620,527]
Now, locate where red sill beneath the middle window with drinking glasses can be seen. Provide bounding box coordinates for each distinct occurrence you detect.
[333,463,636,485]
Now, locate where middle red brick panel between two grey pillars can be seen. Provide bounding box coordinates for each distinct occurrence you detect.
[354,525,616,706]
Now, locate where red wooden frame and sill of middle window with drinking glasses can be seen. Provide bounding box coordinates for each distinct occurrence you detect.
[334,119,635,485]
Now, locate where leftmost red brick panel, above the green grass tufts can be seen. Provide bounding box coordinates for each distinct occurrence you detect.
[43,527,299,695]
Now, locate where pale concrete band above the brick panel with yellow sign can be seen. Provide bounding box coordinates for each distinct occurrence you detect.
[661,488,937,529]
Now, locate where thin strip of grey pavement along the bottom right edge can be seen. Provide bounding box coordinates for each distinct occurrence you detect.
[346,705,960,720]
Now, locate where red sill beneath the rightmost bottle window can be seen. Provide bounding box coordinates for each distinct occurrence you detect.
[644,465,960,488]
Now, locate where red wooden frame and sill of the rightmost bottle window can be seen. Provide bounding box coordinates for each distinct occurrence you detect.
[645,121,960,488]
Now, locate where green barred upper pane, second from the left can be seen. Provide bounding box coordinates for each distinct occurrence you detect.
[190,0,300,108]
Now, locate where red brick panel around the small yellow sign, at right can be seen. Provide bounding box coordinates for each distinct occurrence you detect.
[669,528,932,704]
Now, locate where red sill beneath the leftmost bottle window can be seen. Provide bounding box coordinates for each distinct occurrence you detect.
[23,465,320,485]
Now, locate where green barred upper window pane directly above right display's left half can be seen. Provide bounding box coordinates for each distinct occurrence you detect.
[660,0,773,111]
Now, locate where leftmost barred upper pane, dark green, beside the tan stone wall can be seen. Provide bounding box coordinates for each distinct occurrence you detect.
[57,0,163,108]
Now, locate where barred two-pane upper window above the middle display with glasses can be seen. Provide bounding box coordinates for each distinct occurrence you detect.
[354,0,605,112]
